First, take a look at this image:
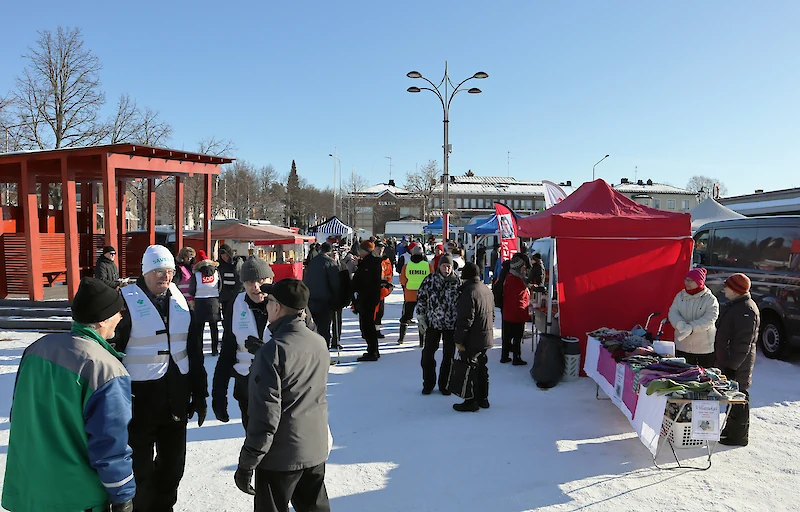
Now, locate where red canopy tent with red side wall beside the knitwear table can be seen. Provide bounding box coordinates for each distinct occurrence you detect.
[517,179,692,368]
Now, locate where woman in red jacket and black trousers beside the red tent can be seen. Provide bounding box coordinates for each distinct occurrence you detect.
[500,254,531,366]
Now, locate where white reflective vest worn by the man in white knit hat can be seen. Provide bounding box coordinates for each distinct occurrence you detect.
[122,283,192,382]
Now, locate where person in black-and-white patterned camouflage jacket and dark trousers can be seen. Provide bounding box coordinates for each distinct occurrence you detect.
[417,254,461,395]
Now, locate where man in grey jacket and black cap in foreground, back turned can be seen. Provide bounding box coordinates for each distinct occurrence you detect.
[234,279,330,512]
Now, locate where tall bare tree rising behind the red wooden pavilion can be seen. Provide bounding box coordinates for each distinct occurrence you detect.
[14,27,106,149]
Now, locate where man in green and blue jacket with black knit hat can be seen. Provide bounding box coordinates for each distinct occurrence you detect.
[2,277,136,512]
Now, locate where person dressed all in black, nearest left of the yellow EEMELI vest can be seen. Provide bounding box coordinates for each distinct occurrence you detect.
[353,240,382,361]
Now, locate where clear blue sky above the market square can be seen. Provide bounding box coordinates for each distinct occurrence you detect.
[0,0,800,195]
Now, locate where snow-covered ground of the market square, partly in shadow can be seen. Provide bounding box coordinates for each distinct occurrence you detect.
[0,289,800,512]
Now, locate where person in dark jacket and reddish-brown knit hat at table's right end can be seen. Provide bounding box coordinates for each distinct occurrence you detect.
[714,274,761,446]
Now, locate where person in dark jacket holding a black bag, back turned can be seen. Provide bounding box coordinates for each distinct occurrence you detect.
[453,262,494,412]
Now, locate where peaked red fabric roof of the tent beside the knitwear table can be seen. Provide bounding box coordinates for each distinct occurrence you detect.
[517,179,692,238]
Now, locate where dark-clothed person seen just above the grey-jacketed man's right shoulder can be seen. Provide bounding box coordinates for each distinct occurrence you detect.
[303,242,341,348]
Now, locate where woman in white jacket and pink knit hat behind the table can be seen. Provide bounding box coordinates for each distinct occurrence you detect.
[669,268,719,368]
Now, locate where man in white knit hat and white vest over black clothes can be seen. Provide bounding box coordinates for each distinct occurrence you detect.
[115,245,208,512]
